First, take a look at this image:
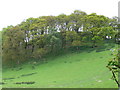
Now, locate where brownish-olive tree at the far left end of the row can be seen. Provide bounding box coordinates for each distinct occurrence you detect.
[3,26,25,65]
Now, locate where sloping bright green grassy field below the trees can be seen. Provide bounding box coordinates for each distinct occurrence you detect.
[3,45,117,88]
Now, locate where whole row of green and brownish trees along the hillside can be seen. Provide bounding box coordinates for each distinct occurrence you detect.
[2,10,119,65]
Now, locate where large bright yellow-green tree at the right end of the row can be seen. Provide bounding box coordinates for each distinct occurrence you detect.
[83,13,116,47]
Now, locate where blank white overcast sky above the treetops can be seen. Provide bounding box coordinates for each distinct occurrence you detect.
[0,0,120,30]
